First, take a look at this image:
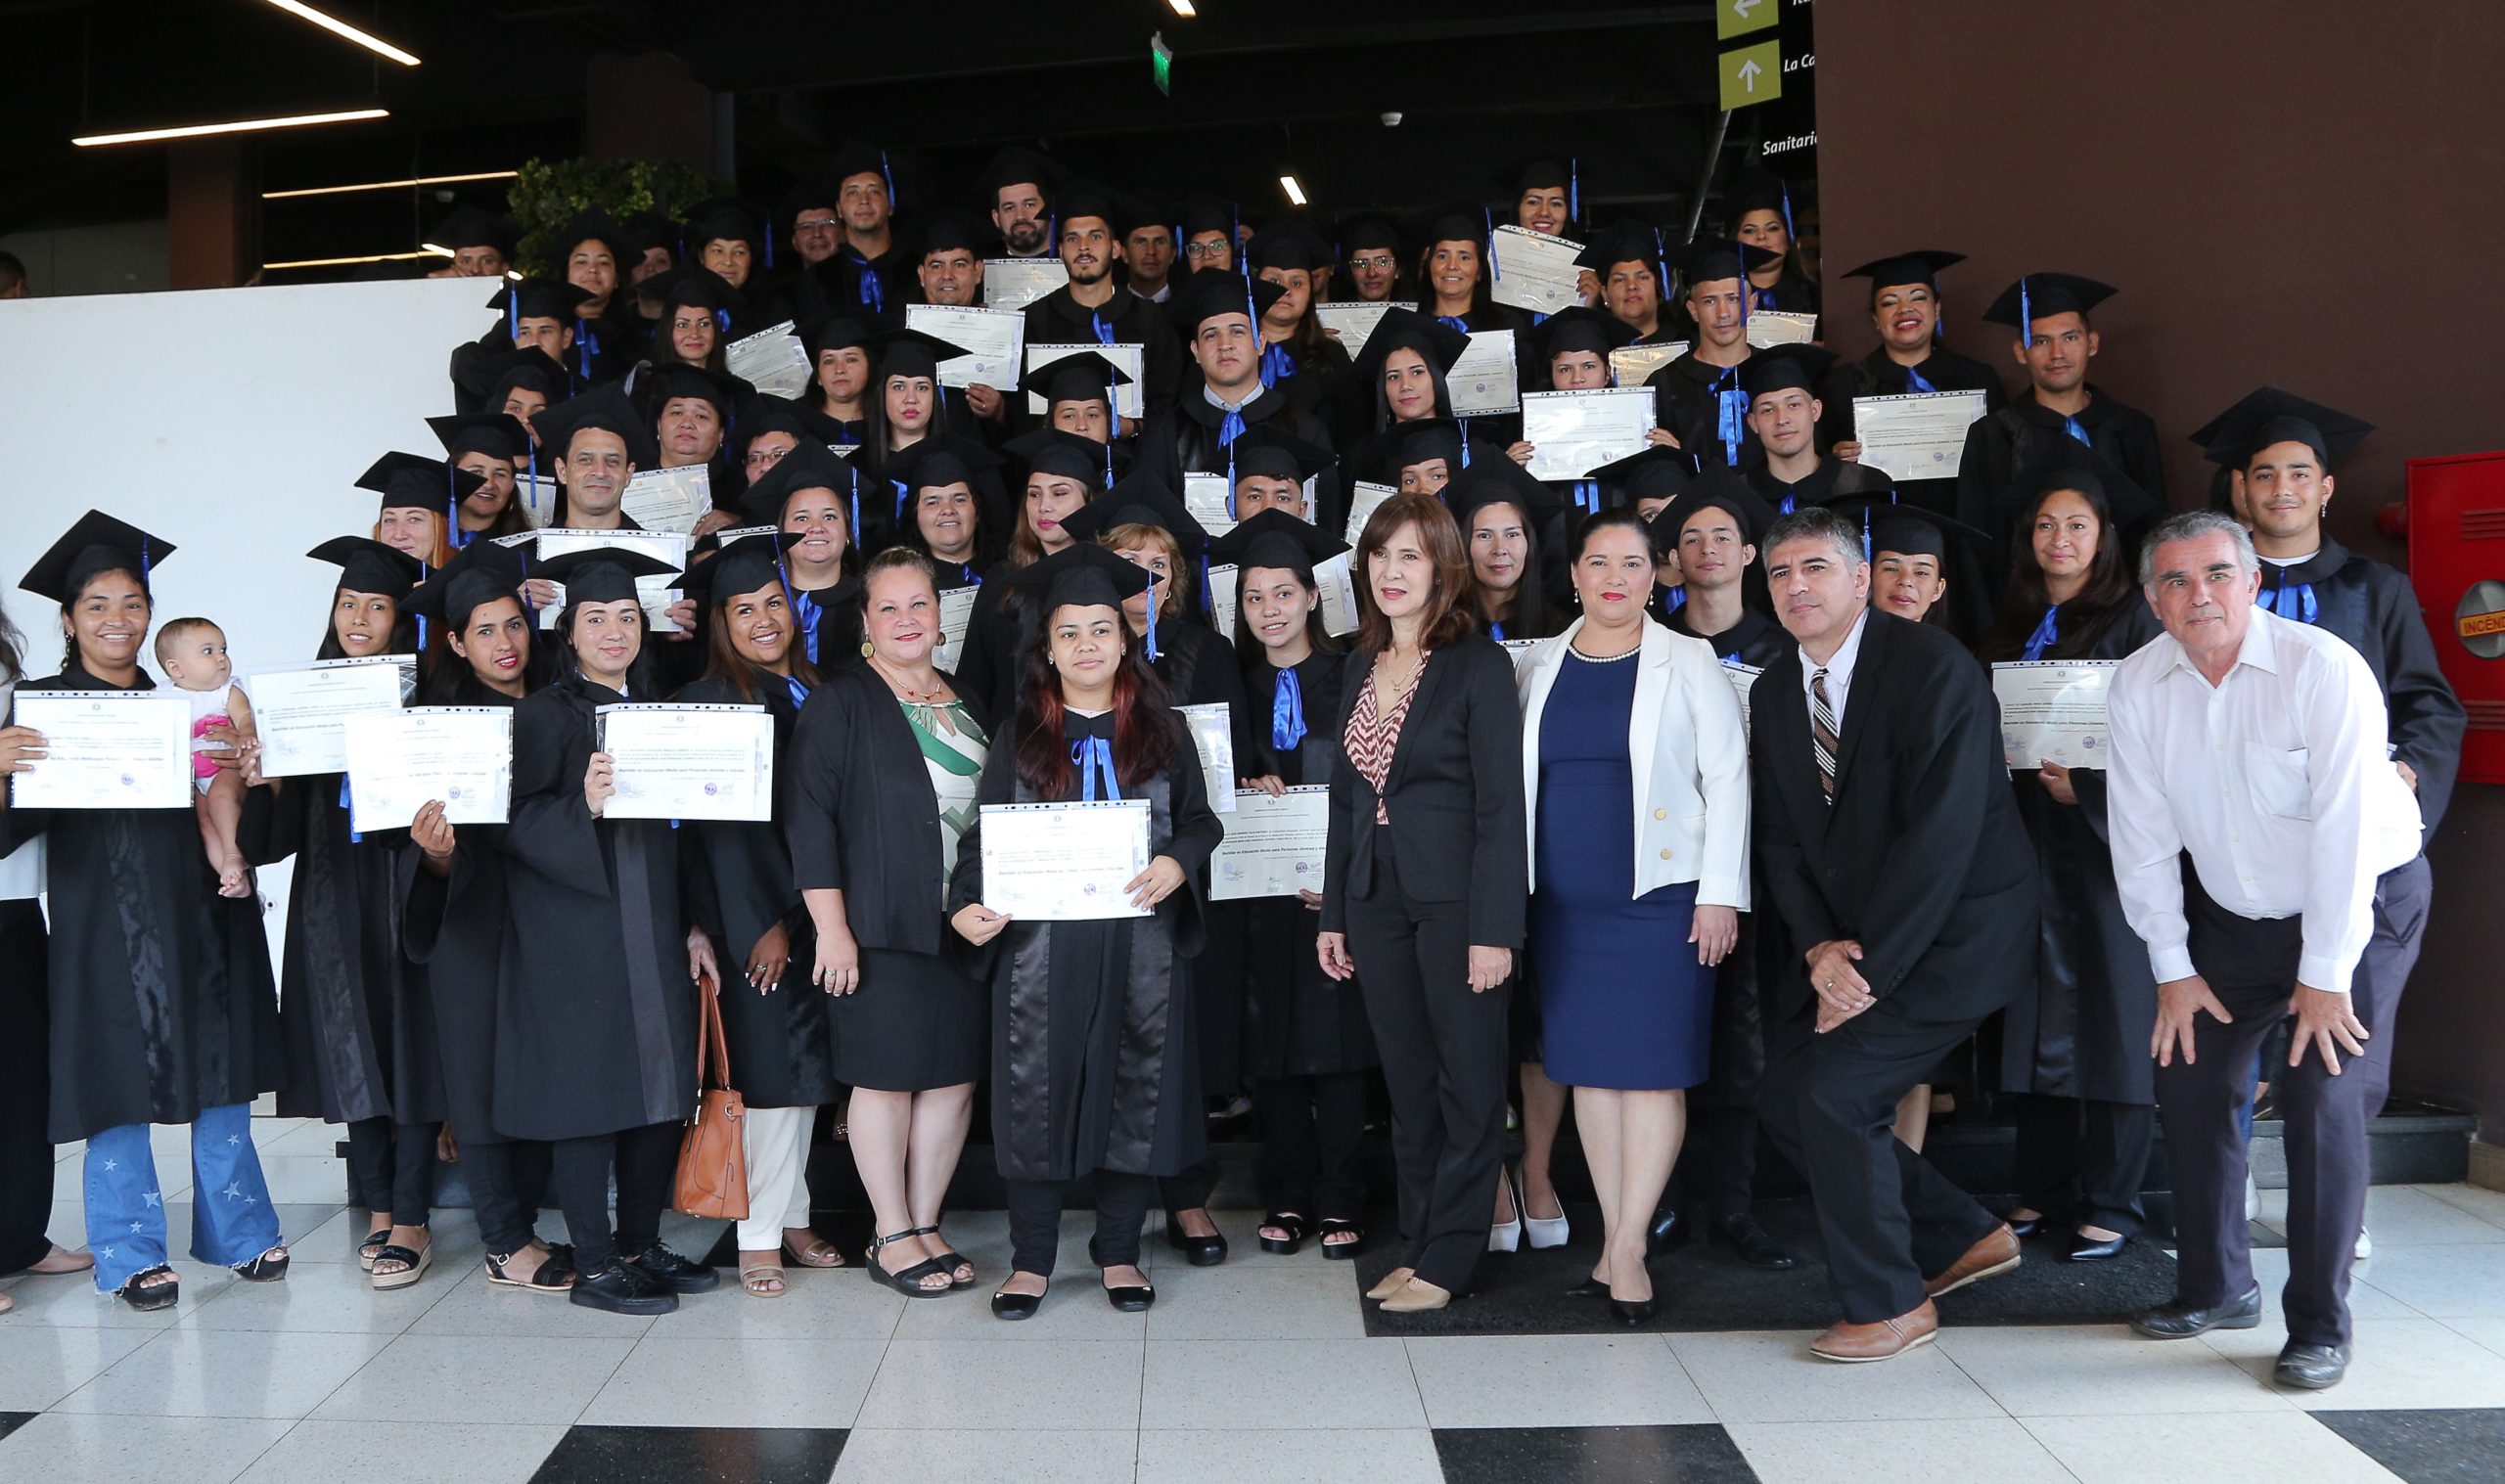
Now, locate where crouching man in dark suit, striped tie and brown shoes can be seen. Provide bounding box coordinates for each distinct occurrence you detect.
[1749,508,2036,1362]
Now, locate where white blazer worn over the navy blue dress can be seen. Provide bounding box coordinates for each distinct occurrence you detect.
[1513,618,1749,911]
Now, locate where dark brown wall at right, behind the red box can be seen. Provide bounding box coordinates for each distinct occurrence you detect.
[1816,0,2505,1142]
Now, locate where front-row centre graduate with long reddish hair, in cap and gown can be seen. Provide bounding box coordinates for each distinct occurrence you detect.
[949,543,1222,1319]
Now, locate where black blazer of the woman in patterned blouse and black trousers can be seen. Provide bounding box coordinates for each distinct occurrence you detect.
[1323,633,1530,949]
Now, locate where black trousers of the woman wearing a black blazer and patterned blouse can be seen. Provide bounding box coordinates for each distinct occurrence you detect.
[1347,831,1513,1294]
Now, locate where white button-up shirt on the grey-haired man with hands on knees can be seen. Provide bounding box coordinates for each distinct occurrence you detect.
[2107,608,2420,994]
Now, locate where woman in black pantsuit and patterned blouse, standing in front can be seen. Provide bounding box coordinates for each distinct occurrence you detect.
[1315,493,1528,1314]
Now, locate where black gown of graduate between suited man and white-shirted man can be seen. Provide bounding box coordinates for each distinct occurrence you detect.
[1999,593,2162,1106]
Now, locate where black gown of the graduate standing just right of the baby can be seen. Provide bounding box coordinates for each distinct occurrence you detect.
[241,773,443,1124]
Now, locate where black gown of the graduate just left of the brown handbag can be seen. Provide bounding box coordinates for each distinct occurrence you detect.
[496,673,697,1139]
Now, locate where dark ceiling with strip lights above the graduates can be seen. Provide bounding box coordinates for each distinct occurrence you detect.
[0,0,1779,269]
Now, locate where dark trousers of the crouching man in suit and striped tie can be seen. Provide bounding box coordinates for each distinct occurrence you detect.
[1758,999,1999,1324]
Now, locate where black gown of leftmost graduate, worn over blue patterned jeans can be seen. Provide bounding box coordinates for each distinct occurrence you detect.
[0,668,286,1144]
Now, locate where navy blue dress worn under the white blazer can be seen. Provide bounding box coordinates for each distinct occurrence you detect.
[1530,651,1713,1091]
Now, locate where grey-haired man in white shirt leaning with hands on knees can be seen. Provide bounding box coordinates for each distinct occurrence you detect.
[2110,511,2428,1391]
